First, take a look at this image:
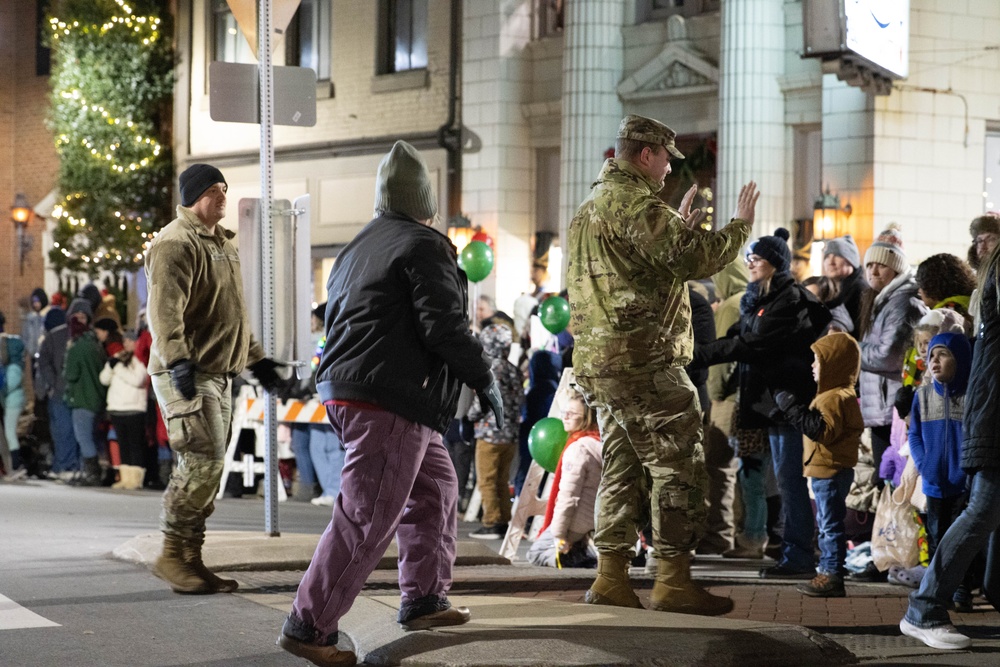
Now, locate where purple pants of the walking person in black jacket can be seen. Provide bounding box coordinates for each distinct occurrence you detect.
[289,405,458,643]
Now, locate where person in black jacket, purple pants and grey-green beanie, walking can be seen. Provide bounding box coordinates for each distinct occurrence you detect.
[278,141,503,664]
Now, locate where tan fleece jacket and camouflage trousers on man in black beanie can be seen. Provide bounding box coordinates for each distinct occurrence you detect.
[146,206,264,541]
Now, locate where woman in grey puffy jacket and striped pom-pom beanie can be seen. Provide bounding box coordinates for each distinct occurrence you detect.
[859,224,927,488]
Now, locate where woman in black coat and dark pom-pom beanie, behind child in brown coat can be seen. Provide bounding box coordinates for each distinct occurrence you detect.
[695,228,830,578]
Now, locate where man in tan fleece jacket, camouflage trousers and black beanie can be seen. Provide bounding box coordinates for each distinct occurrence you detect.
[146,164,283,593]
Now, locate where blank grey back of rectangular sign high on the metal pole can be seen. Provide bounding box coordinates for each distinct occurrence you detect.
[208,61,316,127]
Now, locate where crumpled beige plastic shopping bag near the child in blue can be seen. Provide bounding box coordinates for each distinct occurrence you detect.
[872,477,920,572]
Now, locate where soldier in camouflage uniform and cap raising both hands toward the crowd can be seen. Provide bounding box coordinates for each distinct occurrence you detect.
[567,115,759,615]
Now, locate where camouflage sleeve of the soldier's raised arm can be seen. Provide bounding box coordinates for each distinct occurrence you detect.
[630,197,751,281]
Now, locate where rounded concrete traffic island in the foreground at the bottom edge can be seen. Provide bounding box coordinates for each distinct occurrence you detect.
[341,595,856,667]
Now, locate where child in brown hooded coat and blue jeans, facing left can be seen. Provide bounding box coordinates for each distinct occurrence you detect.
[775,333,864,597]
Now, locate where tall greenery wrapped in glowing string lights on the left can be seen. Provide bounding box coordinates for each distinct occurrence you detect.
[48,0,174,276]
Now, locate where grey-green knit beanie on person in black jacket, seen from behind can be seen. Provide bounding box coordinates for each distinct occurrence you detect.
[375,141,437,220]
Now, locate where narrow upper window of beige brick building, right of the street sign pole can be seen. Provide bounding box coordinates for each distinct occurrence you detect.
[379,0,427,74]
